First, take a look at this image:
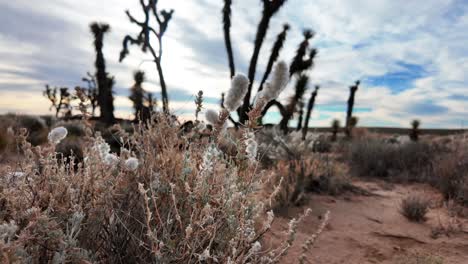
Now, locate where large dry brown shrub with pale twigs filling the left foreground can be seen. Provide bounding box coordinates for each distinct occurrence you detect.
[0,116,316,263]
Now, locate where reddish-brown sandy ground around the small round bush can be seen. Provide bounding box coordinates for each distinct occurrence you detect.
[264,182,468,264]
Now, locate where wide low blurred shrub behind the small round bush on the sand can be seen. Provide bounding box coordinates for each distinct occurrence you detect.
[347,139,435,180]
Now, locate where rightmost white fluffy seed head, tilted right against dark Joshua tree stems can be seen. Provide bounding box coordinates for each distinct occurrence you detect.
[262,61,289,102]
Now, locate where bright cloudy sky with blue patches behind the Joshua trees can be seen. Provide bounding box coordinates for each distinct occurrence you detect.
[0,0,468,128]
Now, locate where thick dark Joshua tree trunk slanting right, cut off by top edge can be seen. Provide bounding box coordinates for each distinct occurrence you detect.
[239,0,286,124]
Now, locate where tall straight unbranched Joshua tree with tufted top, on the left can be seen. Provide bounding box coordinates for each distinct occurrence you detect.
[90,22,115,124]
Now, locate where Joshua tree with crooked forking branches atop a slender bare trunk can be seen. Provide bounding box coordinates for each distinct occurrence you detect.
[120,0,174,114]
